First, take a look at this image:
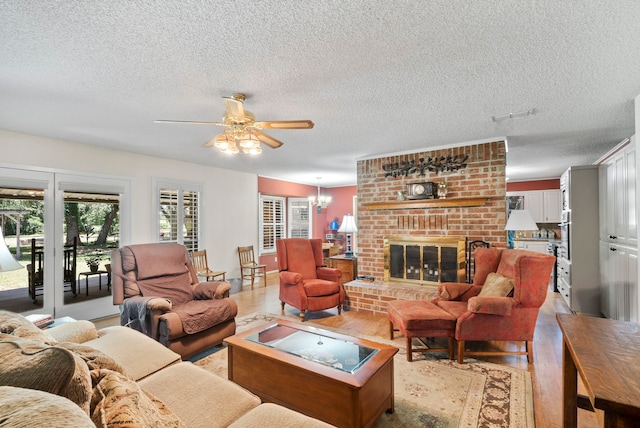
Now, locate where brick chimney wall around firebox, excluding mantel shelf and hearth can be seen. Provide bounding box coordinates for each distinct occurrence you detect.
[357,141,507,280]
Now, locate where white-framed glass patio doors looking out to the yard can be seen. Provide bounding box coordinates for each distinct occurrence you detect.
[0,168,130,319]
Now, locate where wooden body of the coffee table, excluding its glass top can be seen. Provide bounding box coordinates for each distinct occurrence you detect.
[225,320,398,427]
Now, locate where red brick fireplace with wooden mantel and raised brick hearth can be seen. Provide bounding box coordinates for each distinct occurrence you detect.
[345,141,507,313]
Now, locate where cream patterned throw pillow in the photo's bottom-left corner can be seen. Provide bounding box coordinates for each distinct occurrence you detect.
[0,386,95,428]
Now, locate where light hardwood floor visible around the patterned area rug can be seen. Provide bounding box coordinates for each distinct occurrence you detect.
[94,273,603,428]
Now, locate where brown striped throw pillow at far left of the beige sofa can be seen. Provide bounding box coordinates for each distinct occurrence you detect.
[0,338,91,414]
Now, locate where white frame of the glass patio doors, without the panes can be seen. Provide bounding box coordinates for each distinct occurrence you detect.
[0,168,131,319]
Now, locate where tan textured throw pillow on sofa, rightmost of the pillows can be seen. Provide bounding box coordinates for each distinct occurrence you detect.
[91,370,188,428]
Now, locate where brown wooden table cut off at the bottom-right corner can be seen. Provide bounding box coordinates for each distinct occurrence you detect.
[556,314,640,428]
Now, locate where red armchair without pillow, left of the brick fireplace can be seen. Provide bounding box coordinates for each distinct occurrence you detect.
[276,238,344,321]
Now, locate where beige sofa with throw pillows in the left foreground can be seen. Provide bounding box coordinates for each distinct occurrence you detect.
[0,311,330,428]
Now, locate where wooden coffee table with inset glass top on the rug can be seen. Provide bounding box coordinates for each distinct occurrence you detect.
[225,320,398,427]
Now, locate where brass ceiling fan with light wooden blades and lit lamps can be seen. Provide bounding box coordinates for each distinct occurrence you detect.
[155,94,313,154]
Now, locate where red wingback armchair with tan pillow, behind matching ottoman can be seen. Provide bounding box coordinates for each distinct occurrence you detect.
[434,248,555,363]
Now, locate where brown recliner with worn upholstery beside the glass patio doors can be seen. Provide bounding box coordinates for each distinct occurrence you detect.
[111,243,238,358]
